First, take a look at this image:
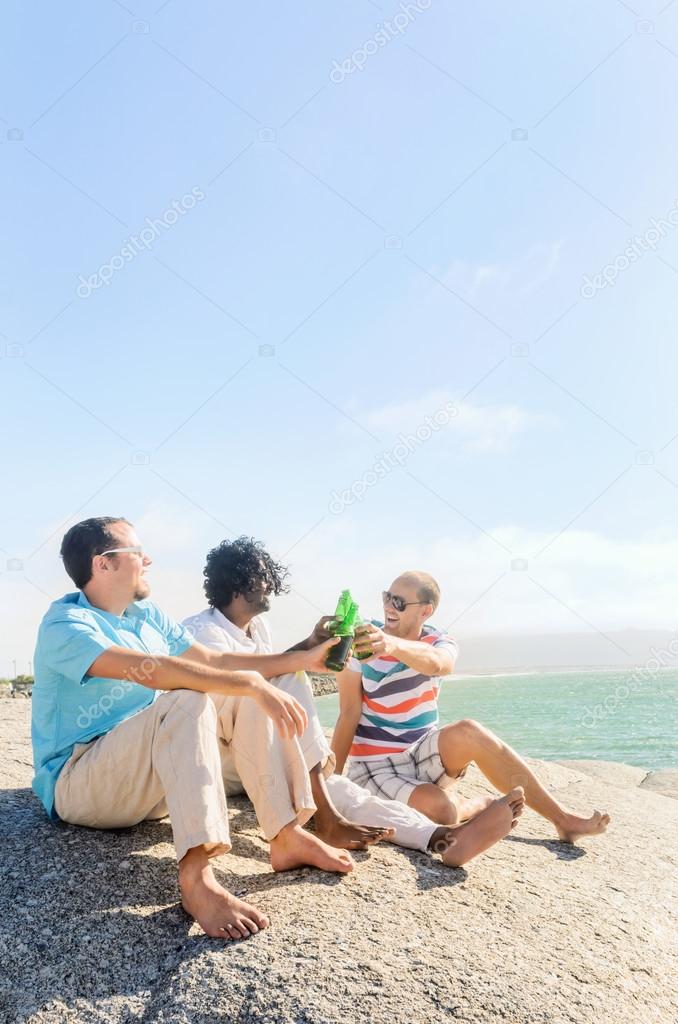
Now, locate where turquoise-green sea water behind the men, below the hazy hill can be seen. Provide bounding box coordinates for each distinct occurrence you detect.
[316,669,678,769]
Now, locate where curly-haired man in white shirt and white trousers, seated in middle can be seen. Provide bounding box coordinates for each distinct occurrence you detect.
[183,537,520,866]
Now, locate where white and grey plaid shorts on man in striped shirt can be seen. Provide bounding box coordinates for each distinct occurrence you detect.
[347,729,463,804]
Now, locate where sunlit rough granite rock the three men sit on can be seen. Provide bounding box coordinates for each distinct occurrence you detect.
[0,700,678,1024]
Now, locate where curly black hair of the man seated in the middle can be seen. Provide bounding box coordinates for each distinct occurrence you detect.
[203,537,290,608]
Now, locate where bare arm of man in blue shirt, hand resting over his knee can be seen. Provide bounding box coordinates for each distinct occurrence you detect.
[87,645,307,739]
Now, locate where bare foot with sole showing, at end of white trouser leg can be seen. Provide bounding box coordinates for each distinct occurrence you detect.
[430,785,525,867]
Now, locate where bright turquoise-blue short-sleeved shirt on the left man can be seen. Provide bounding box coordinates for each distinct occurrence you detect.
[31,591,193,819]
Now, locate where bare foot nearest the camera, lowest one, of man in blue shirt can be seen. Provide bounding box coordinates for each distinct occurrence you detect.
[179,847,269,939]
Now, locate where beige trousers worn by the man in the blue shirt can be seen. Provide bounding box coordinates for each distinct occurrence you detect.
[55,690,315,860]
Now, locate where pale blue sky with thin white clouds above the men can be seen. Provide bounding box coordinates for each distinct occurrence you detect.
[0,0,678,674]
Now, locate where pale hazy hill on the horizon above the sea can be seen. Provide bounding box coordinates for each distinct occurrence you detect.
[457,630,678,673]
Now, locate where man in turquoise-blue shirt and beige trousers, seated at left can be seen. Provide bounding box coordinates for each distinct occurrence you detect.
[32,517,353,939]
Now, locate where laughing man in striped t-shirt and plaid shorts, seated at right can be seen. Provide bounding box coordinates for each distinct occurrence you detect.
[332,571,609,843]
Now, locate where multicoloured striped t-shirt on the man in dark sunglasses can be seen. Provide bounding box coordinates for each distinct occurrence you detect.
[347,622,458,761]
